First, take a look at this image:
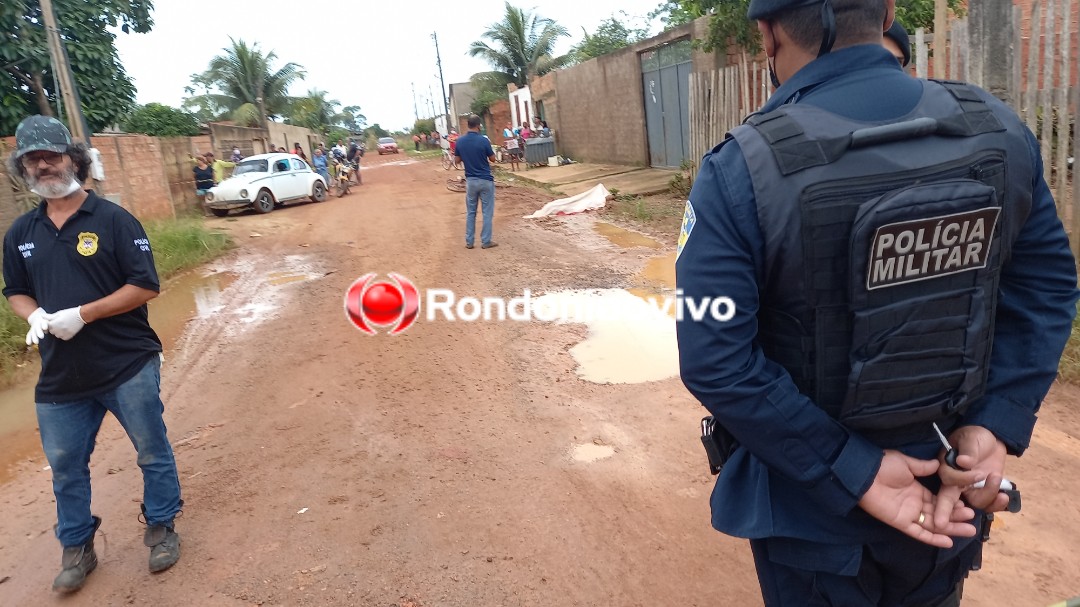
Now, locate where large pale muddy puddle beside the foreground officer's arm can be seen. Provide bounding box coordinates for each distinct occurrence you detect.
[536,288,678,383]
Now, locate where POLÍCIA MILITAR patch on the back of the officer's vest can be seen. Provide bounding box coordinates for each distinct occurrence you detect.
[864,206,1001,291]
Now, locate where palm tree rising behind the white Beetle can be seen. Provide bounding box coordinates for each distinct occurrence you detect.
[194,38,305,124]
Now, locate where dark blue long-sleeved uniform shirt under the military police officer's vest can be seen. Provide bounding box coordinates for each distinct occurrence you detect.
[675,45,1078,540]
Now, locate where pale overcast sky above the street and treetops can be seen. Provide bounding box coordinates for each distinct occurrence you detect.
[116,0,661,130]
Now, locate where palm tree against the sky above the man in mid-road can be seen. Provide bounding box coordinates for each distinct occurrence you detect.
[469,2,570,86]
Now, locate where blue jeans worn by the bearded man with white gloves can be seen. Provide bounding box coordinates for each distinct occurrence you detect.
[38,355,180,547]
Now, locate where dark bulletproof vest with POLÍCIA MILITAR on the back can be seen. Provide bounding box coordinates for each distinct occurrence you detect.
[730,81,1034,446]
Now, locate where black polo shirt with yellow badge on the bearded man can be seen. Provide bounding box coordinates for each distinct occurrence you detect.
[3,191,161,403]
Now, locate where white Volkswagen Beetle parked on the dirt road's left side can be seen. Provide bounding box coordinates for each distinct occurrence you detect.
[205,152,326,217]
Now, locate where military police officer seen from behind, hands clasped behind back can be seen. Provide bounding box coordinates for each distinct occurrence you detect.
[676,0,1078,607]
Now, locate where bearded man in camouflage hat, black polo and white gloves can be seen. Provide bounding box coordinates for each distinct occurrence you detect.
[3,116,184,592]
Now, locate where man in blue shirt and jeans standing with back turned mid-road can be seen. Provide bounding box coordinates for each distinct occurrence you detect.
[454,114,498,248]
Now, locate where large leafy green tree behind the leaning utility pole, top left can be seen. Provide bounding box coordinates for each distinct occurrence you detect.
[0,0,153,135]
